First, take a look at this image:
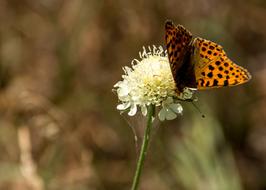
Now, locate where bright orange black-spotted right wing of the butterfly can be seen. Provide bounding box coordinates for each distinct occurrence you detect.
[191,38,251,90]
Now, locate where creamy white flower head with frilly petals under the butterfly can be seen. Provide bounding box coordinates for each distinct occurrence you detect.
[114,46,193,121]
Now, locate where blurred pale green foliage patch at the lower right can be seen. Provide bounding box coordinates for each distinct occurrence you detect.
[173,115,242,190]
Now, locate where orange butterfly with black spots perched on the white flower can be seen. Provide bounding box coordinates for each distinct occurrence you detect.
[165,21,251,93]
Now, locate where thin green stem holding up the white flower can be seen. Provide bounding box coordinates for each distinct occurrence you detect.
[131,105,155,190]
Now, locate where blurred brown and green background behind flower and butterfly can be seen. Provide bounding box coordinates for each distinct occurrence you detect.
[0,0,266,190]
